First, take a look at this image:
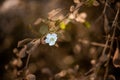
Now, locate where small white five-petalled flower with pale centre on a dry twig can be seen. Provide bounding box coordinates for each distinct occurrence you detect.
[45,33,57,46]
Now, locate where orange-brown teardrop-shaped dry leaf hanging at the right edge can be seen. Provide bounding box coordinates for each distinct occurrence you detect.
[113,48,120,68]
